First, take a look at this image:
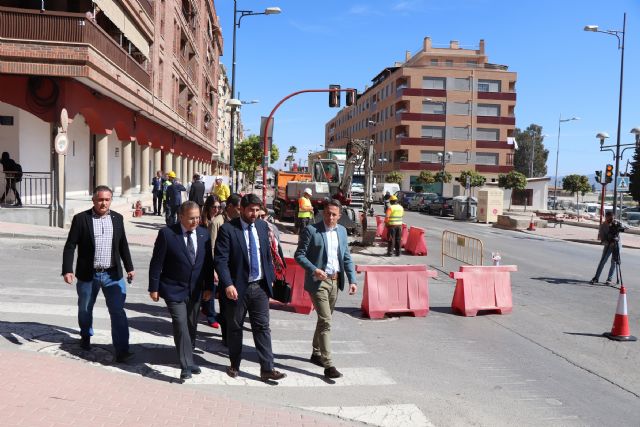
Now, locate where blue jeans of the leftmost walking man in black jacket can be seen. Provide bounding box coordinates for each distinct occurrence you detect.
[76,271,129,355]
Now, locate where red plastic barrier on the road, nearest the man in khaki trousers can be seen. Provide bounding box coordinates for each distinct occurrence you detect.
[356,265,438,319]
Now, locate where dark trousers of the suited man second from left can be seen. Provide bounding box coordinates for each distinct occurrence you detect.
[166,293,200,369]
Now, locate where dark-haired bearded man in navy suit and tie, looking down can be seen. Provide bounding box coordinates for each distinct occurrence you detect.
[214,194,286,381]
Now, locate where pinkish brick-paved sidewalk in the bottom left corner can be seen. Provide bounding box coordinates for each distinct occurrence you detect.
[0,349,353,427]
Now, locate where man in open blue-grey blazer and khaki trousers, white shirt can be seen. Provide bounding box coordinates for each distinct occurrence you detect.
[294,200,358,378]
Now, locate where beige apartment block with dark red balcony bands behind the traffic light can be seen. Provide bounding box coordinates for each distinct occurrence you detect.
[325,37,516,195]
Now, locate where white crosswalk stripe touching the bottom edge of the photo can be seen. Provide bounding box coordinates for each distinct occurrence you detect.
[301,404,433,427]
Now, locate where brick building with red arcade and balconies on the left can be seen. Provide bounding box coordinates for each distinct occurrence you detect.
[0,0,224,224]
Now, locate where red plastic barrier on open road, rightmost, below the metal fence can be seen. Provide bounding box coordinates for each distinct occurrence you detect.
[449,265,518,316]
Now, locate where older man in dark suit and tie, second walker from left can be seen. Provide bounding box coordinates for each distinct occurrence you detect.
[149,202,213,380]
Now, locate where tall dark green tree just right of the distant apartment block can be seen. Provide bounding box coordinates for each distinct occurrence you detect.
[513,124,549,178]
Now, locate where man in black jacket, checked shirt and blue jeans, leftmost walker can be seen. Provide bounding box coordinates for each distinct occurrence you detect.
[62,185,135,363]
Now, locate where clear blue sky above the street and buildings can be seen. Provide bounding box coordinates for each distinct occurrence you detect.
[215,0,640,176]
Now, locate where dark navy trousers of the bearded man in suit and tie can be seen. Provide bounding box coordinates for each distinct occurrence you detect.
[224,279,273,372]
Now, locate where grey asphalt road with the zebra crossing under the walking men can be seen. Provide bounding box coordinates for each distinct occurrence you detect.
[0,206,640,426]
